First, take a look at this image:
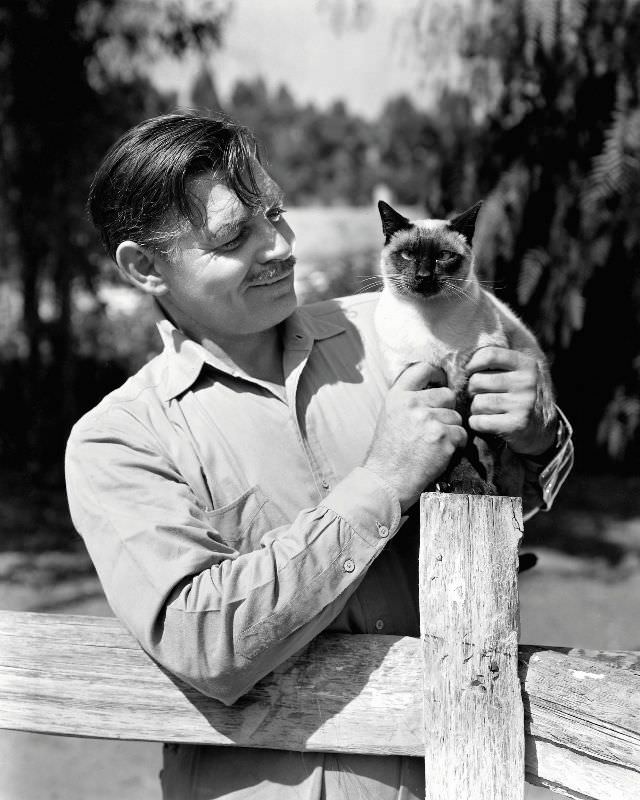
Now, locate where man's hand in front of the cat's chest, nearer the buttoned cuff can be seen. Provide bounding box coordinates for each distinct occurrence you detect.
[364,363,467,512]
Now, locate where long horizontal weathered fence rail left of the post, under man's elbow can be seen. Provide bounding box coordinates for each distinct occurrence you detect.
[0,612,423,755]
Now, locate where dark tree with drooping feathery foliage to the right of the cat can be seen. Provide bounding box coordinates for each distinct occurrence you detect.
[404,0,640,466]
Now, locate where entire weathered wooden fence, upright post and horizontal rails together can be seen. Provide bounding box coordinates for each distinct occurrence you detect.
[0,494,640,800]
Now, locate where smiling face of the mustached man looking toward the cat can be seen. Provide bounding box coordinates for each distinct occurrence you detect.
[155,165,296,342]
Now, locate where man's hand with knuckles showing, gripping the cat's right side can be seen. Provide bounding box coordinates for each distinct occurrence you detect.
[467,347,558,456]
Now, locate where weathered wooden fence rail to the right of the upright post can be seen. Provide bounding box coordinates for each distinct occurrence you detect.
[519,646,640,800]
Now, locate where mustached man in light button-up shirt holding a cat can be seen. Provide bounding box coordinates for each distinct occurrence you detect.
[67,114,571,800]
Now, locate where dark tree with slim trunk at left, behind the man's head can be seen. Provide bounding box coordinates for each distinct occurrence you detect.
[0,0,224,472]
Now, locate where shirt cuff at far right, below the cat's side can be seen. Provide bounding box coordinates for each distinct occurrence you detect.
[521,408,573,521]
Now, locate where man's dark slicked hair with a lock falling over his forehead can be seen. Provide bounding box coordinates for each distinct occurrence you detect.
[88,113,261,260]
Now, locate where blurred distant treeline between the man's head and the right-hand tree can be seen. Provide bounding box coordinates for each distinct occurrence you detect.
[191,71,475,216]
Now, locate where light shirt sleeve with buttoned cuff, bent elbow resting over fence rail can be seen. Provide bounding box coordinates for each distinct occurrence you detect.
[66,412,400,704]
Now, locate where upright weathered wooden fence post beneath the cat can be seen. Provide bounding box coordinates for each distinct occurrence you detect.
[420,493,524,800]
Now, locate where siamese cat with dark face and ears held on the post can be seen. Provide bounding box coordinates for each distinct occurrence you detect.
[375,201,555,496]
